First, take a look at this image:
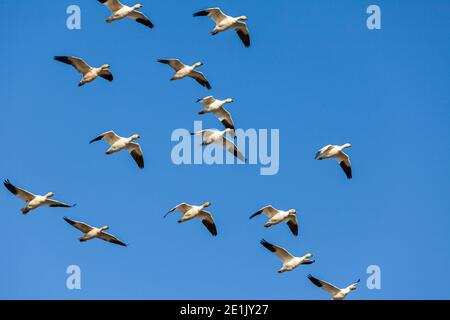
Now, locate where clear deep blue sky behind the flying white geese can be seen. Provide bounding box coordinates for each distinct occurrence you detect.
[0,0,450,299]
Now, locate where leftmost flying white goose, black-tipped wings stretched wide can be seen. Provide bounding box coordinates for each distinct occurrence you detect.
[3,180,75,214]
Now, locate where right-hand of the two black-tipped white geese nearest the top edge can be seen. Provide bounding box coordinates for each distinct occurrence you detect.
[194,8,250,48]
